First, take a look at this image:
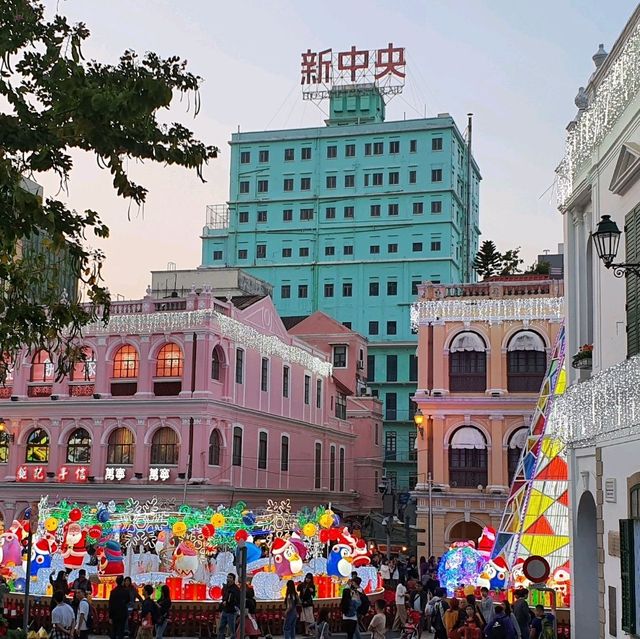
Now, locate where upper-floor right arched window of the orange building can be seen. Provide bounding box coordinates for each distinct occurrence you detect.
[507,331,547,393]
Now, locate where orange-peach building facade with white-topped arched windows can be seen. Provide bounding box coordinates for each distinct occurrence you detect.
[413,276,564,556]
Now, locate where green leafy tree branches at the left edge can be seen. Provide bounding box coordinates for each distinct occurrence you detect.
[0,0,218,383]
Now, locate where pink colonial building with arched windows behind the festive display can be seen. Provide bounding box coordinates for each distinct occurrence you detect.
[0,288,382,521]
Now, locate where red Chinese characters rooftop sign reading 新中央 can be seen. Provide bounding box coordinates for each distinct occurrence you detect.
[300,42,406,100]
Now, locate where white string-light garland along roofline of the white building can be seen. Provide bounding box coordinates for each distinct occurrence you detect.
[556,20,640,206]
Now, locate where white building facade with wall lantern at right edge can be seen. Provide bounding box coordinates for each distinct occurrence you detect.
[552,9,640,638]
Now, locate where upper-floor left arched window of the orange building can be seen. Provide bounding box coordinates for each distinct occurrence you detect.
[449,331,487,393]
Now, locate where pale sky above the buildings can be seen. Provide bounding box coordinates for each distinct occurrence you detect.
[38,0,636,299]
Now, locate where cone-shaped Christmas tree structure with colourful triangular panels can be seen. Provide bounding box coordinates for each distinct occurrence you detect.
[492,327,569,575]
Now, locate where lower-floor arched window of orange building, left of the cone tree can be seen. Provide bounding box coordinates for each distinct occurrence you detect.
[449,426,487,488]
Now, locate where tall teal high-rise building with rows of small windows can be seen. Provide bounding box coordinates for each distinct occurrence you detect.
[202,87,481,491]
